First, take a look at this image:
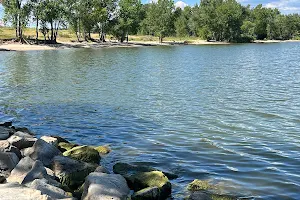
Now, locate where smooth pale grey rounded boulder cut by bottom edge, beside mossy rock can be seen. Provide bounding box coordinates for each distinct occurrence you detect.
[82,172,130,200]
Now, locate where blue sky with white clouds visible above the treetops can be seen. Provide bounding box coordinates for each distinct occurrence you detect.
[0,0,300,19]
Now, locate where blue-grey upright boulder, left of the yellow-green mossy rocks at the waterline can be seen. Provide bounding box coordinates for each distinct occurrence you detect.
[29,139,61,166]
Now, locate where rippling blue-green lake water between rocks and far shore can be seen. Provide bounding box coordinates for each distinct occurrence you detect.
[0,43,300,199]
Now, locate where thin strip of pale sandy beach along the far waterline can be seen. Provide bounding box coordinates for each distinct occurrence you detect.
[0,40,300,51]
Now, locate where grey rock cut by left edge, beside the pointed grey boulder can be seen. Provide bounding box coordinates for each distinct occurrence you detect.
[0,152,19,176]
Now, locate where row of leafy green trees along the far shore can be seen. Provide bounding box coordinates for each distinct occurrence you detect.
[0,0,300,43]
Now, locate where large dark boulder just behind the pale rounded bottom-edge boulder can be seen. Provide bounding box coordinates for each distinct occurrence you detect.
[51,156,97,190]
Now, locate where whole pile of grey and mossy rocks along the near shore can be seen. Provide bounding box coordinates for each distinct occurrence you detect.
[0,122,237,200]
